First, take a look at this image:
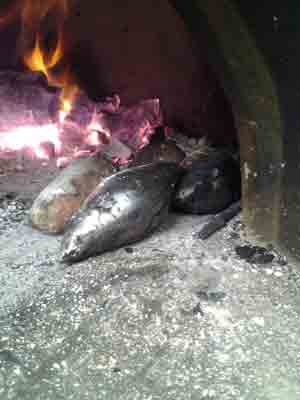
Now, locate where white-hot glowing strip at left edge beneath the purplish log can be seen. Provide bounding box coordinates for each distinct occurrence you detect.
[0,124,61,159]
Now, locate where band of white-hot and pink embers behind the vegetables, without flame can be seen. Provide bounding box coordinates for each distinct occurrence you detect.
[0,94,163,166]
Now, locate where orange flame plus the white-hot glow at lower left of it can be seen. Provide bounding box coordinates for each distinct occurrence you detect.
[0,0,84,163]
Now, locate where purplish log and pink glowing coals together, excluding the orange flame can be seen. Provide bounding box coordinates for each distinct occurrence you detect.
[0,71,163,164]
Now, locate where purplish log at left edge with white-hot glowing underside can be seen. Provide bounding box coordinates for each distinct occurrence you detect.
[0,71,60,164]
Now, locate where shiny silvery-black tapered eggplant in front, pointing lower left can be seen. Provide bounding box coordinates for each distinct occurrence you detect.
[62,162,181,263]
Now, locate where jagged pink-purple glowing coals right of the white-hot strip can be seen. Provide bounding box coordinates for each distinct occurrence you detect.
[60,93,163,157]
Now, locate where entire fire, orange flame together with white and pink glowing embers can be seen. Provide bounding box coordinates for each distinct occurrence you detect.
[0,0,163,166]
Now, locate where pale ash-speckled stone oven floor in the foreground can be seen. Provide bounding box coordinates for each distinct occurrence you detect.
[0,164,300,400]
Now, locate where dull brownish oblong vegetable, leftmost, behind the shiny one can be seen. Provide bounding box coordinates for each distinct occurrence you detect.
[30,155,115,233]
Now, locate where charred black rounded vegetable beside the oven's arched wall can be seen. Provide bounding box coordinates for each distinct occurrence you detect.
[173,150,241,214]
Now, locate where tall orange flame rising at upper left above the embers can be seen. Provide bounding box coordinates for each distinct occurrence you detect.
[0,0,79,121]
